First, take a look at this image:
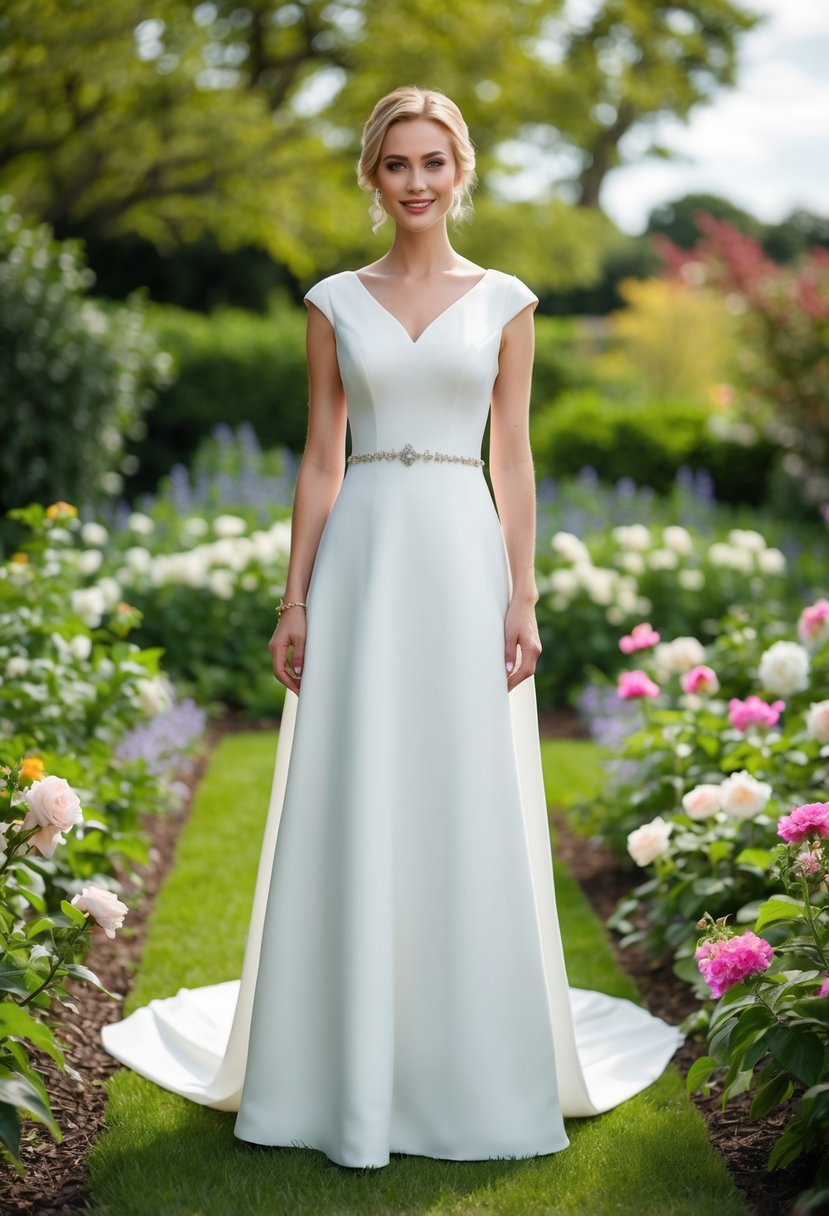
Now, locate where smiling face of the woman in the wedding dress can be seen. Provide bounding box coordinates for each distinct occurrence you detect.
[377,118,459,231]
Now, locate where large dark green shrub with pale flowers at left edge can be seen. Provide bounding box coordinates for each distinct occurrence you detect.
[0,195,164,514]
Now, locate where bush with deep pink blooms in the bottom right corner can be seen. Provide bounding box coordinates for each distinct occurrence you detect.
[687,801,829,1211]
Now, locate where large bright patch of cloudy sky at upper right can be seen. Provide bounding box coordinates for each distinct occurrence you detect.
[602,0,829,232]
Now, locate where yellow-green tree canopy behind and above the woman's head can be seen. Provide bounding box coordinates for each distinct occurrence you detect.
[0,0,755,288]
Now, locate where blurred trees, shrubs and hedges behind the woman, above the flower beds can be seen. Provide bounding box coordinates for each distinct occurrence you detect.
[0,0,829,530]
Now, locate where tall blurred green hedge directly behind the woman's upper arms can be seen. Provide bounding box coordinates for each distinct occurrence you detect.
[129,304,585,496]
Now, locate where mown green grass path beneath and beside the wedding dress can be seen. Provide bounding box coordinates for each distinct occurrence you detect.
[90,733,744,1216]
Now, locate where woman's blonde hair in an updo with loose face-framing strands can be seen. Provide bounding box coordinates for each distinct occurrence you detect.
[357,84,476,232]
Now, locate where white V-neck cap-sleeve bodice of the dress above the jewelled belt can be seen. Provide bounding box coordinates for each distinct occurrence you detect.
[305,270,537,456]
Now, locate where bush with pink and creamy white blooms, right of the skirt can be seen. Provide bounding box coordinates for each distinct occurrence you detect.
[576,593,829,991]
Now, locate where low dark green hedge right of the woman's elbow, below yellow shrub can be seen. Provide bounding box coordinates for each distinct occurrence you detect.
[531,389,777,506]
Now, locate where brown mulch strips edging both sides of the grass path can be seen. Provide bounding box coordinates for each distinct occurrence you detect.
[0,711,808,1216]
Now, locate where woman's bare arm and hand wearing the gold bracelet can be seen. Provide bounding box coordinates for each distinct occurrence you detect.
[267,303,346,693]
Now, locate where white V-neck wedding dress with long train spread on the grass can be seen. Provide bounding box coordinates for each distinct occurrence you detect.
[103,270,681,1166]
